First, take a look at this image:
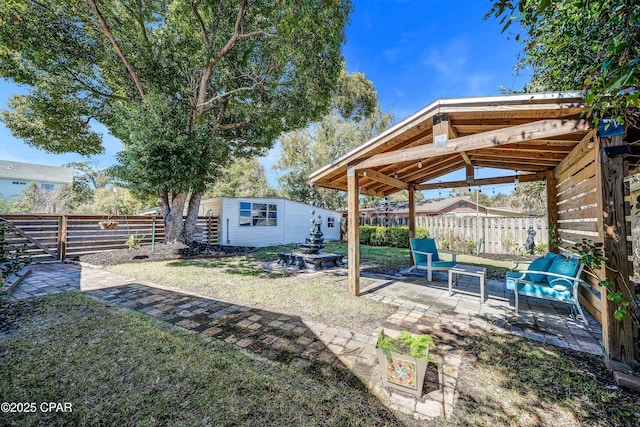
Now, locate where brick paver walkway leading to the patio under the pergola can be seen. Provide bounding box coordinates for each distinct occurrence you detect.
[5,264,601,418]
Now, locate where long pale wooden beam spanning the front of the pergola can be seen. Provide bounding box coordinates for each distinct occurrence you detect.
[356,119,589,169]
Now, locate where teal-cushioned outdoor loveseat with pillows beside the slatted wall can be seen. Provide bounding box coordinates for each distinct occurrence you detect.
[506,252,588,326]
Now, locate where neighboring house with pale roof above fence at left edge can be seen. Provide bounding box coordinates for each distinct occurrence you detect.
[0,160,73,199]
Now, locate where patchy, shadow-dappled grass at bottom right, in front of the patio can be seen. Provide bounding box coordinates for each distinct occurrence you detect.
[447,333,640,426]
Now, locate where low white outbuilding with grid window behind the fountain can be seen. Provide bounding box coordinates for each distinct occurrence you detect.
[140,197,341,247]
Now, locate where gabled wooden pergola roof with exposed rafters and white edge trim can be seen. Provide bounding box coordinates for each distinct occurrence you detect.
[309,91,592,197]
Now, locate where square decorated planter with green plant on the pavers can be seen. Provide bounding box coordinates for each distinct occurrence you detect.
[376,331,434,397]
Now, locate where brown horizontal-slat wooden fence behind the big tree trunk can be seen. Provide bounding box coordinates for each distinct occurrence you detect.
[0,214,218,262]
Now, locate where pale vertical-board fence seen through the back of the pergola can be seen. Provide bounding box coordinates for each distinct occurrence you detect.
[360,215,549,254]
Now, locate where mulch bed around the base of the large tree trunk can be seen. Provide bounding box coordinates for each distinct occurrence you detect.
[78,242,255,265]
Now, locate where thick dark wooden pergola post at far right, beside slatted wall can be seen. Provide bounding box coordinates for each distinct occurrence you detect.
[596,135,634,365]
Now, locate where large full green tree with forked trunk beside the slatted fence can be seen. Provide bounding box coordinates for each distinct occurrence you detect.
[0,0,351,241]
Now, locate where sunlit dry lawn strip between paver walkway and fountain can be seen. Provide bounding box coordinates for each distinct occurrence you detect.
[108,253,395,335]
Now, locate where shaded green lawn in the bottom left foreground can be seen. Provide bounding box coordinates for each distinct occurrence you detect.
[0,292,401,426]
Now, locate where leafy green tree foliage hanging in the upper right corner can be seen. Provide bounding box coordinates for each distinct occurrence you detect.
[487,0,640,126]
